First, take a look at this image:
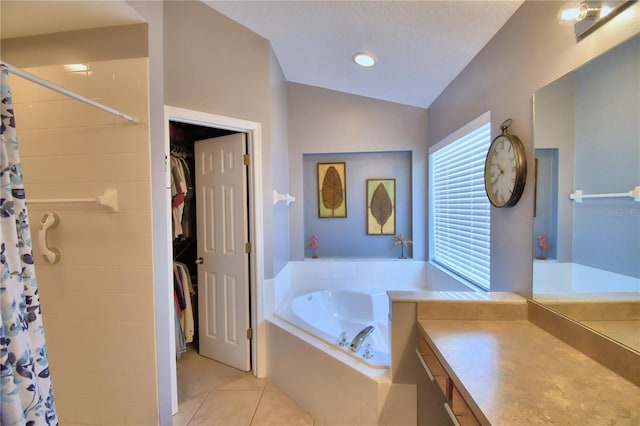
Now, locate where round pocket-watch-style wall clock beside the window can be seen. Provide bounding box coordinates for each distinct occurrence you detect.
[484,119,527,207]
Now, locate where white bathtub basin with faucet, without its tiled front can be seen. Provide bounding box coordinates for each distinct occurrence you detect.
[275,289,390,369]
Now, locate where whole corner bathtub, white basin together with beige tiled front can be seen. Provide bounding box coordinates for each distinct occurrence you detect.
[267,288,418,426]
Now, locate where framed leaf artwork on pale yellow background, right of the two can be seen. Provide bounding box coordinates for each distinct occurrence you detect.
[367,179,396,235]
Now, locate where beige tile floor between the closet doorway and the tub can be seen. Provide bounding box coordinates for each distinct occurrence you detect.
[173,347,317,426]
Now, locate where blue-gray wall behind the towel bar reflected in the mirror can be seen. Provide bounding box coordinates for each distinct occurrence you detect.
[573,36,640,277]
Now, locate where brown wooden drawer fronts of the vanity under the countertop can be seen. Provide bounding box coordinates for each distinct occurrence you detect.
[416,336,481,426]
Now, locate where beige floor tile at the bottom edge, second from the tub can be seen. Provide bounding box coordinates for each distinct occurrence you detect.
[189,391,262,426]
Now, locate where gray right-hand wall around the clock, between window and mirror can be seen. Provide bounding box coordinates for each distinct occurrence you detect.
[427,1,640,297]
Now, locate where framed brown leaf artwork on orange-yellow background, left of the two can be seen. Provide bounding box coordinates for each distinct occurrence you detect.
[318,162,347,218]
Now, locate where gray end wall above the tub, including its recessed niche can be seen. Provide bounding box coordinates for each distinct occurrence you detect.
[288,83,428,260]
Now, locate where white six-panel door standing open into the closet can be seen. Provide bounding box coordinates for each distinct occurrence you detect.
[195,133,251,371]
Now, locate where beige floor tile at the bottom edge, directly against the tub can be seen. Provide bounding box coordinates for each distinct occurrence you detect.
[251,392,313,426]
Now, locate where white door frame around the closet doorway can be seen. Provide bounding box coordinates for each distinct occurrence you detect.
[165,105,266,414]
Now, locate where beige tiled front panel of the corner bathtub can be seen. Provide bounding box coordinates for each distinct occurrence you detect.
[267,318,417,426]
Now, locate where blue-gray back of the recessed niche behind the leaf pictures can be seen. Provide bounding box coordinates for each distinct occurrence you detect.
[303,151,413,258]
